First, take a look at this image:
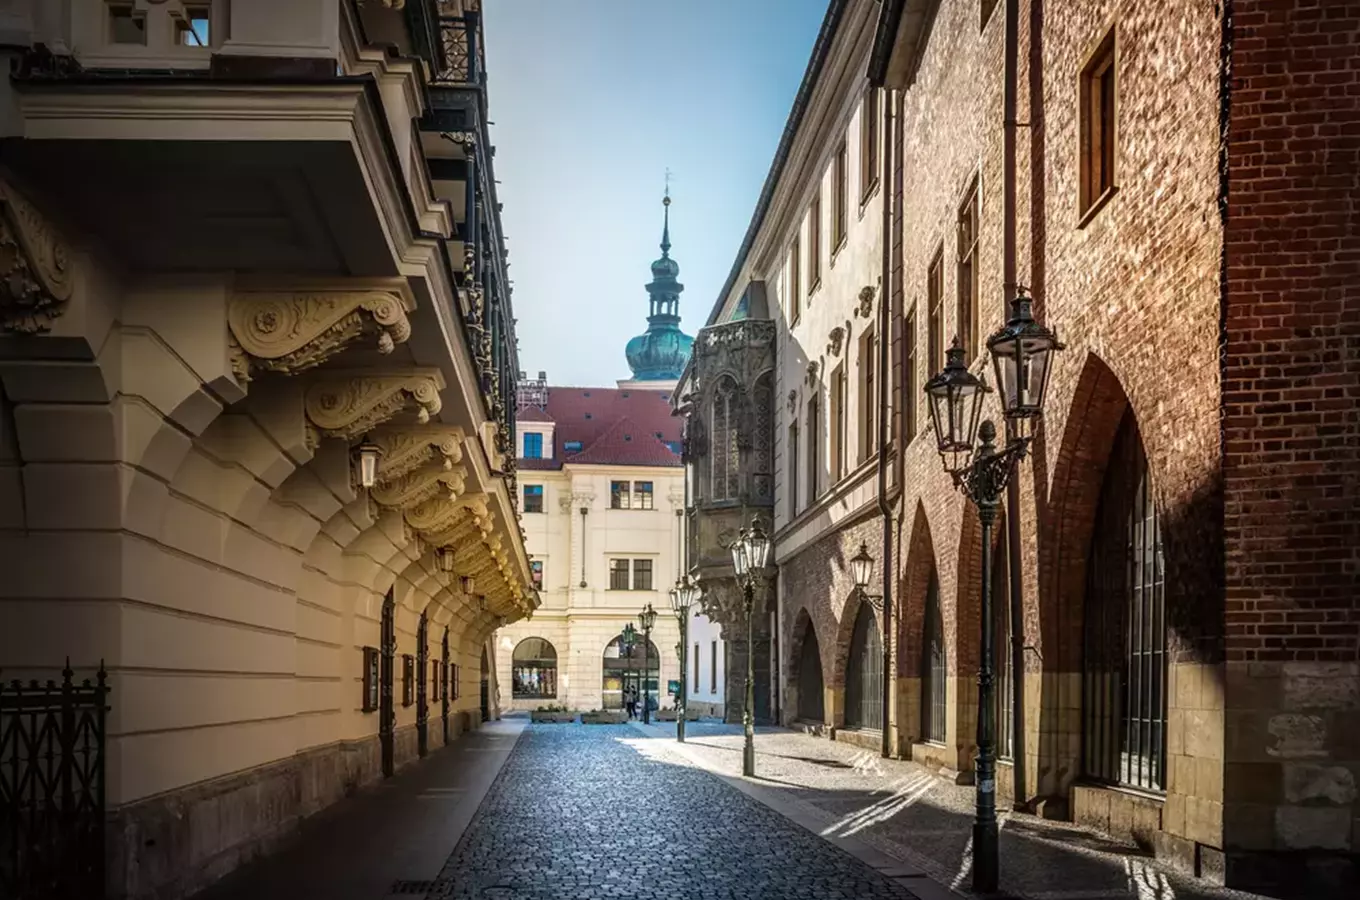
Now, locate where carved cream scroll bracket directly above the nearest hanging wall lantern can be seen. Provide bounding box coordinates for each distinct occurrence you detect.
[303,368,443,440]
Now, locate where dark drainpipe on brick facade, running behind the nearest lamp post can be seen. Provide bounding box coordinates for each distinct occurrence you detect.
[987,0,1030,810]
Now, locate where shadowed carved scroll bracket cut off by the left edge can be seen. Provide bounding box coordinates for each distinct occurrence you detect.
[0,182,72,334]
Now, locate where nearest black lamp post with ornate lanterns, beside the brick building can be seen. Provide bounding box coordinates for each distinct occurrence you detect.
[925,290,1062,893]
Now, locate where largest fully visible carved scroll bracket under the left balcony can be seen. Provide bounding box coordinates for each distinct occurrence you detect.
[227,290,415,382]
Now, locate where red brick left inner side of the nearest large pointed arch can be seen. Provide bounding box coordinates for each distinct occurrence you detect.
[1039,353,1130,672]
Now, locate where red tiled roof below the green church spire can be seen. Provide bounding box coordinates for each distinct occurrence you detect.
[518,387,680,469]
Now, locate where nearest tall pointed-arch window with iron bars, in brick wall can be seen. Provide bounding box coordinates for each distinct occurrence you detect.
[1081,409,1167,791]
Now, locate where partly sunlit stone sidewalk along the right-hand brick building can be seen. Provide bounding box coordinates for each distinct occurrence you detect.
[634,722,1263,900]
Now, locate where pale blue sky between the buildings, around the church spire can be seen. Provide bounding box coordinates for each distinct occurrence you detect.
[483,0,827,386]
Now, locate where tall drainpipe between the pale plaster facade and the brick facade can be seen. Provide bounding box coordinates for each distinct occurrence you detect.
[874,86,897,759]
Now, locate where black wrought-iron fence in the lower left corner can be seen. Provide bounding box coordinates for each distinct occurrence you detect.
[0,661,109,900]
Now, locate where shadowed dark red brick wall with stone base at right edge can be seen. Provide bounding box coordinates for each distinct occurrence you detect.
[1223,0,1360,890]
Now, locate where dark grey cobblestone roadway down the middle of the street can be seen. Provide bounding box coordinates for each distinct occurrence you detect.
[428,725,915,900]
